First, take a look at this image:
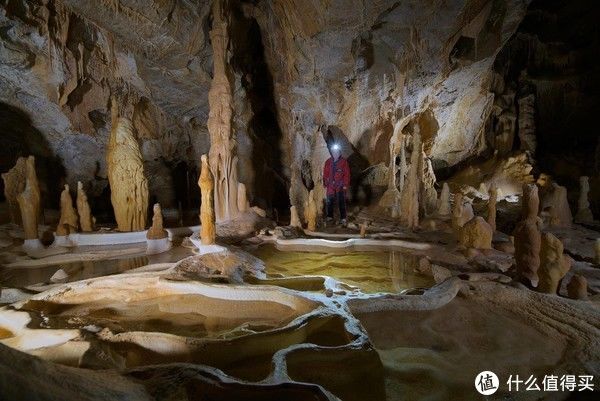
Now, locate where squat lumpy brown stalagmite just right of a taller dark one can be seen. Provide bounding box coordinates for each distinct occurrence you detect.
[537,233,571,294]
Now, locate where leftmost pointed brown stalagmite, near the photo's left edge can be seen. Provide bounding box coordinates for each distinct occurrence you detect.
[17,156,40,240]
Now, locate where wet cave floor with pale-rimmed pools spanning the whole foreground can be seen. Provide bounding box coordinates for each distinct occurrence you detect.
[0,219,600,400]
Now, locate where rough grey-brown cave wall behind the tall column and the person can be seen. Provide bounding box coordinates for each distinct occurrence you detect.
[0,0,540,219]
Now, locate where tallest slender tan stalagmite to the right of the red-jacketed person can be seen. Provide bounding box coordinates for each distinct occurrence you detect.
[400,128,423,229]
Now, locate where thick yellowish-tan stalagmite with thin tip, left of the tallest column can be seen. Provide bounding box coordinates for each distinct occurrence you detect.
[107,99,148,231]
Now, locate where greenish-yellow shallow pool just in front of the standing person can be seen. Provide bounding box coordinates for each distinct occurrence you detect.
[247,244,434,294]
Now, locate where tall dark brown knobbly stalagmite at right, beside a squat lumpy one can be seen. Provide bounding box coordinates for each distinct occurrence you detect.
[513,184,542,287]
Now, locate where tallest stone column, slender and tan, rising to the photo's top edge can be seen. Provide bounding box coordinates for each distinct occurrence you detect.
[207,0,238,221]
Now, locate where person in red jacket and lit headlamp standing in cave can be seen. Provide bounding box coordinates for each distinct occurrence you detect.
[323,143,350,226]
